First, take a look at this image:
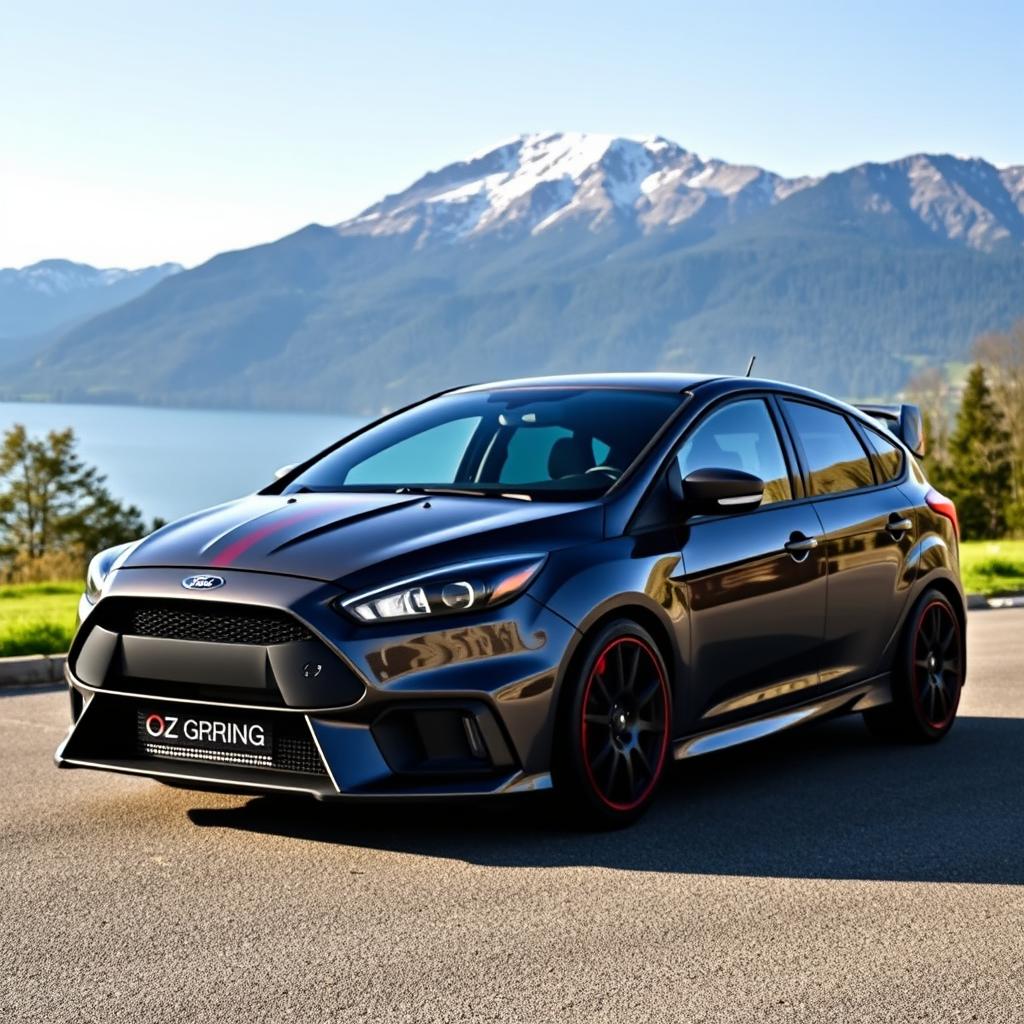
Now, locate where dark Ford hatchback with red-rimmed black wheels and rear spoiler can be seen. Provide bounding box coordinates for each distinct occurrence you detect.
[56,373,967,827]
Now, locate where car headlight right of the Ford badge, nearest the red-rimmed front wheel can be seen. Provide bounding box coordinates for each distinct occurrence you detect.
[340,555,544,623]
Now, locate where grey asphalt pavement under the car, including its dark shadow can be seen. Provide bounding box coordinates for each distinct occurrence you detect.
[0,610,1024,1024]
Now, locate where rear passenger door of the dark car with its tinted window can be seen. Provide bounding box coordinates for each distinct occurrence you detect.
[780,398,915,688]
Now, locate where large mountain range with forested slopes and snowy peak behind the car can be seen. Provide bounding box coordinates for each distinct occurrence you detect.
[0,133,1024,414]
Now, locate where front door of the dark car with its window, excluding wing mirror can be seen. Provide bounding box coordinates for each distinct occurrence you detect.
[677,397,825,723]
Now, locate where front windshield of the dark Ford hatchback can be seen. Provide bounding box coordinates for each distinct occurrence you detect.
[286,388,680,500]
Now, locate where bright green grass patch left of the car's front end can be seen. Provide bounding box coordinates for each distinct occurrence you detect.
[0,583,82,657]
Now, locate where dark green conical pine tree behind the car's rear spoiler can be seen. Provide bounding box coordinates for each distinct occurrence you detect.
[944,364,1012,540]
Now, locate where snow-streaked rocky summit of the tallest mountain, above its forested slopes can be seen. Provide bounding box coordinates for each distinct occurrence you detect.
[337,132,816,246]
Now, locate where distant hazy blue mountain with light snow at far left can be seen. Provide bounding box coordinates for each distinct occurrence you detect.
[0,259,181,358]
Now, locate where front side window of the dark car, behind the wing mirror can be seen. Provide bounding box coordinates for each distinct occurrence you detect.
[677,398,793,505]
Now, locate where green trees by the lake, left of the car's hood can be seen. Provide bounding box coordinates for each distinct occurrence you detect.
[0,424,162,583]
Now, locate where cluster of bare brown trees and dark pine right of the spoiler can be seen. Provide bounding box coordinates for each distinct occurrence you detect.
[907,319,1024,540]
